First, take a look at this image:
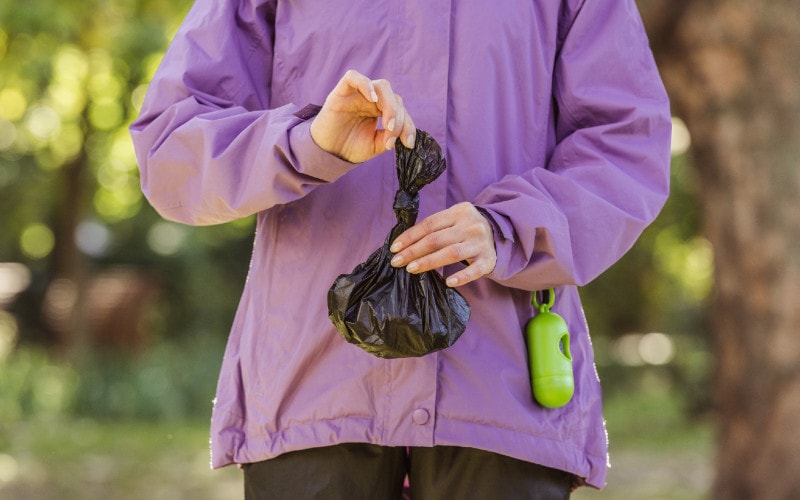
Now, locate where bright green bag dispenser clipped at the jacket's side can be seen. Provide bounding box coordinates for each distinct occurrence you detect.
[525,288,575,408]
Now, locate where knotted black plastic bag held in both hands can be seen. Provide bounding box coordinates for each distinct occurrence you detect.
[328,129,470,358]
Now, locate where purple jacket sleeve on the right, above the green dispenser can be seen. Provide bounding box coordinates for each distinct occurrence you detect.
[474,0,671,290]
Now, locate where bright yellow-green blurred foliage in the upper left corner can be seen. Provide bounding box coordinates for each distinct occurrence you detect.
[0,0,187,239]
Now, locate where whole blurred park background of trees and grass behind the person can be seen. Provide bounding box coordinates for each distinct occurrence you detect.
[0,0,800,500]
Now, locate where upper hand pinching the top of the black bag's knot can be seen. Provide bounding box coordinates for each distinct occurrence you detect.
[311,69,417,163]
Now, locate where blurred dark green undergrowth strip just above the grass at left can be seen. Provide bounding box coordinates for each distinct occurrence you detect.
[0,338,224,422]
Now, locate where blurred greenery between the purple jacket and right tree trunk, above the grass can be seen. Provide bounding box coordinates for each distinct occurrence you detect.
[581,148,713,414]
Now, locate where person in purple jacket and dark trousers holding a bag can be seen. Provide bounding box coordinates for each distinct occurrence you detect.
[131,0,671,498]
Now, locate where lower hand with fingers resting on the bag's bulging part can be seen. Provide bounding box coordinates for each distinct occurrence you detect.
[389,202,497,287]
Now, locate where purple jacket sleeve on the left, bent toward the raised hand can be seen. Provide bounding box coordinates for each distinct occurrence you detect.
[130,0,353,225]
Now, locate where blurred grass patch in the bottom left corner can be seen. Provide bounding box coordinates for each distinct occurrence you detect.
[0,420,242,500]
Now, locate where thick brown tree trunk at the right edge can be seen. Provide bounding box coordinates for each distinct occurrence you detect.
[640,0,800,499]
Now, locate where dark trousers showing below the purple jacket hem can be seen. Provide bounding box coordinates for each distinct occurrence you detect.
[243,443,573,500]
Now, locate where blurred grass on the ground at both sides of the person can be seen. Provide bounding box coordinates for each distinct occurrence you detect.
[0,392,712,500]
